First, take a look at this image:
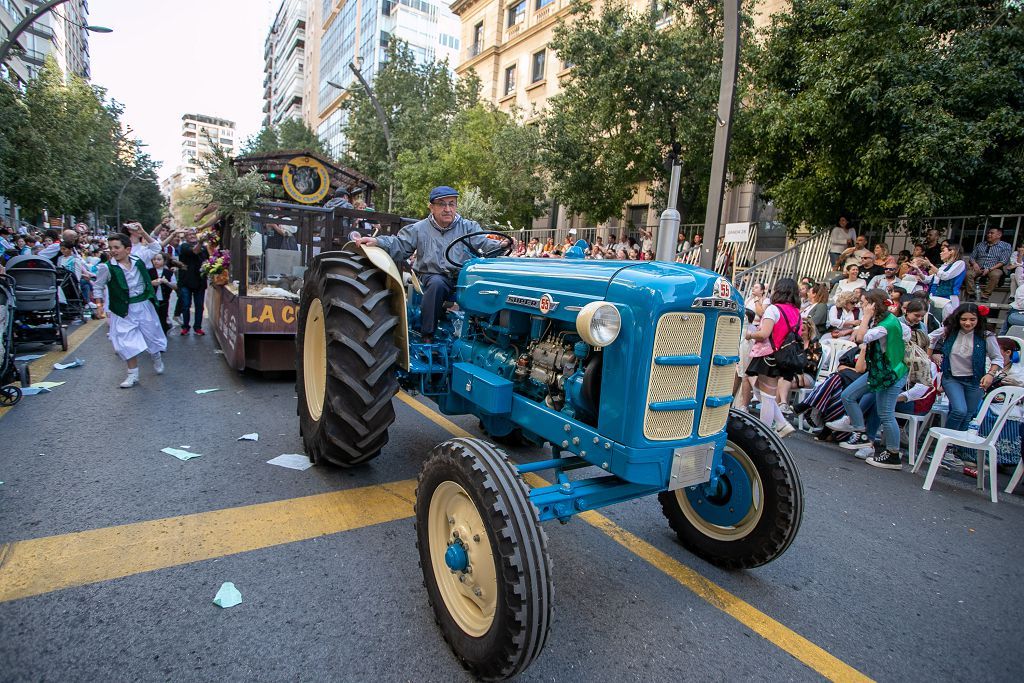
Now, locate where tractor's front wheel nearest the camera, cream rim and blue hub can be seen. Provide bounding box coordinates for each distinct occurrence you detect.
[416,438,552,680]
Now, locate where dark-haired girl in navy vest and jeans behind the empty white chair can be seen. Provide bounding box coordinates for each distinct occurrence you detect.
[931,303,1002,431]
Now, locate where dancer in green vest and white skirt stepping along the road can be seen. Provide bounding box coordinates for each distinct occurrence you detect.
[95,234,167,389]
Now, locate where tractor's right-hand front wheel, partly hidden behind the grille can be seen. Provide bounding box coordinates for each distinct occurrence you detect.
[657,411,804,569]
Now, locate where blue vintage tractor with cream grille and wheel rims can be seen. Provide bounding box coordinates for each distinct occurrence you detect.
[297,238,803,679]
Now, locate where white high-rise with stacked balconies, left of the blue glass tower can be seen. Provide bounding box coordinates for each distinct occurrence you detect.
[263,0,307,126]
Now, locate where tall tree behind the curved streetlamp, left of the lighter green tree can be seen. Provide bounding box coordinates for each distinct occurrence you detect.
[342,40,479,214]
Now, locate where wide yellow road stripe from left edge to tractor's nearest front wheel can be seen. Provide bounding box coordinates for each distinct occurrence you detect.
[0,479,416,602]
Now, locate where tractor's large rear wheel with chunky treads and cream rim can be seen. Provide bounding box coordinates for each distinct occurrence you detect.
[295,252,398,467]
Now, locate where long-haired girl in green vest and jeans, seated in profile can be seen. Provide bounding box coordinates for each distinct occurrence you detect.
[826,290,910,470]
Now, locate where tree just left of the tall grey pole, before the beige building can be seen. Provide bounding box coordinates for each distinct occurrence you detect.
[544,0,723,222]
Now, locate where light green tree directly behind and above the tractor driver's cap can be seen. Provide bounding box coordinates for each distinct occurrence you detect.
[395,102,544,227]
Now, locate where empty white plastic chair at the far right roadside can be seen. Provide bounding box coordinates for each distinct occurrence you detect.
[911,386,1024,503]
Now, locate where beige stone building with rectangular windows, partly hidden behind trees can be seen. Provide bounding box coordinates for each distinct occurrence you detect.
[452,0,788,229]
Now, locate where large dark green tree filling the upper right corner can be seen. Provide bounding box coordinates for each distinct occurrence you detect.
[734,0,1024,225]
